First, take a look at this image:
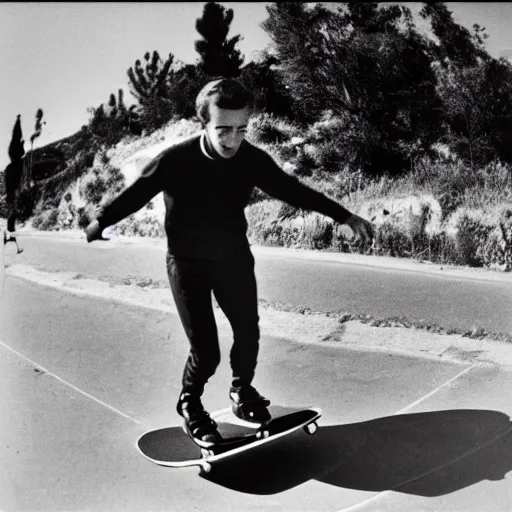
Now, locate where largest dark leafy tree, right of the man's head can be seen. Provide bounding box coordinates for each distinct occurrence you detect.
[262,2,441,174]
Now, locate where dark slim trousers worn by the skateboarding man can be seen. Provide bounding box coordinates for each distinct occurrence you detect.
[167,246,260,396]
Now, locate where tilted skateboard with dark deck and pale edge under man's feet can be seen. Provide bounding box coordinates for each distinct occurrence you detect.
[137,406,322,474]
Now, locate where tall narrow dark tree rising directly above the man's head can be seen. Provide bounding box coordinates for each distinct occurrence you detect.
[195,2,244,78]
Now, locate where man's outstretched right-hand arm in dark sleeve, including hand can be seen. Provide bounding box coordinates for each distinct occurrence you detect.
[256,155,375,244]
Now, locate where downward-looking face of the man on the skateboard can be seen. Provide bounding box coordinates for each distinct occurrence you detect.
[205,105,251,158]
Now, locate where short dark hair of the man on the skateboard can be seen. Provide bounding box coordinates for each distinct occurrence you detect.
[196,78,254,125]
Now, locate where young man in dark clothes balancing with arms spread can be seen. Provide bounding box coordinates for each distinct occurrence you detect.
[86,79,373,444]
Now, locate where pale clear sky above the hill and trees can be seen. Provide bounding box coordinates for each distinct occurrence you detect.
[0,2,512,169]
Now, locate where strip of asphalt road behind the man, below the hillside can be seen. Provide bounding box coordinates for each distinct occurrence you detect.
[6,233,512,334]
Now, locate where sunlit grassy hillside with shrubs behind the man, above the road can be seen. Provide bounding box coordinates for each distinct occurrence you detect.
[0,115,512,271]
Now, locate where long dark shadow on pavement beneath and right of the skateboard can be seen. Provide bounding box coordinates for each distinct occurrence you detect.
[204,409,512,497]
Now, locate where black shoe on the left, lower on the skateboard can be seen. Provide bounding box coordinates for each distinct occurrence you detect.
[176,394,222,448]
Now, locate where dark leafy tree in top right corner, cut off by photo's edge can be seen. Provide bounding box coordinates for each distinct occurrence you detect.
[420,2,512,169]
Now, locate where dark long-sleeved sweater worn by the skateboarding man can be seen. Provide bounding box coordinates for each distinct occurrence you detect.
[98,135,350,259]
